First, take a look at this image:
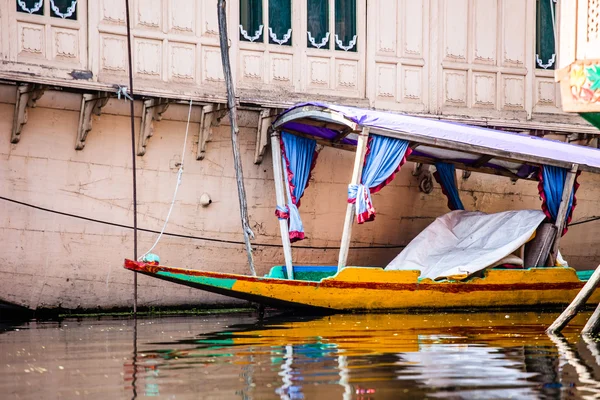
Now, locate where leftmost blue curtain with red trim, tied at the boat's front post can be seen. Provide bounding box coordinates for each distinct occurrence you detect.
[275,132,317,242]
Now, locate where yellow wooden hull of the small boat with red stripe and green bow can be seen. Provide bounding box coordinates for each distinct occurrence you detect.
[125,260,600,311]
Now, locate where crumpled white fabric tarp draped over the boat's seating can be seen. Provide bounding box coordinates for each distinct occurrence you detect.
[385,210,545,280]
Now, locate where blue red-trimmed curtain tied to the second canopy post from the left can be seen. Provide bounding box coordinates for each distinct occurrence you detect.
[348,135,410,224]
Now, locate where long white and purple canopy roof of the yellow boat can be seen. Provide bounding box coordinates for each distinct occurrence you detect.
[272,102,600,180]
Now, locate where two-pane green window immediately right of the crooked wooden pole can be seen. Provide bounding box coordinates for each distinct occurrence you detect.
[240,0,292,46]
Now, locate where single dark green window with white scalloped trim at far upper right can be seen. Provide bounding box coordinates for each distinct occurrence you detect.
[535,0,557,69]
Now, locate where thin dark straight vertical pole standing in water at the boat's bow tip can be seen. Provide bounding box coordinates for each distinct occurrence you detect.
[125,0,137,315]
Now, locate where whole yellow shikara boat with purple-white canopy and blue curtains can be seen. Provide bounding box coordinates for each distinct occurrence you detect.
[124,103,600,311]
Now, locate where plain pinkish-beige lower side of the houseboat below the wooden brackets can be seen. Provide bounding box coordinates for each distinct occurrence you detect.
[0,85,600,308]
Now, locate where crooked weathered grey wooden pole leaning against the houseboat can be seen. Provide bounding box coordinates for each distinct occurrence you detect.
[217,0,256,276]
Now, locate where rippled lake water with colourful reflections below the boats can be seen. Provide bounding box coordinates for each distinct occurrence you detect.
[0,312,600,400]
